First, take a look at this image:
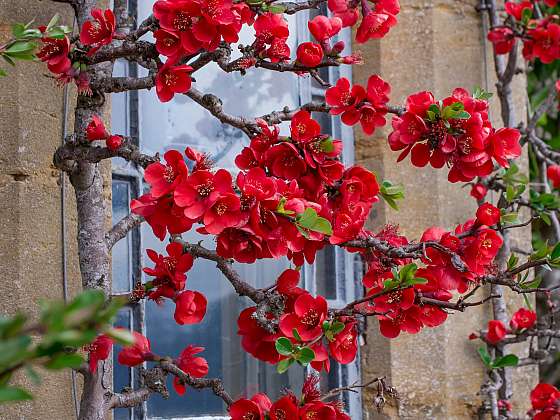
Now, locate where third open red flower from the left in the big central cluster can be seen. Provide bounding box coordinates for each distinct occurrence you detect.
[203,193,243,235]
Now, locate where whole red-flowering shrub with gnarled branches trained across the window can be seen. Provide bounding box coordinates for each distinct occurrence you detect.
[0,0,560,420]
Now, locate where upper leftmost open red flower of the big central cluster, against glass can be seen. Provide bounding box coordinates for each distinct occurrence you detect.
[144,150,189,198]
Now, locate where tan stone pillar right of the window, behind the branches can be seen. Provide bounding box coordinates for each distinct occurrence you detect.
[354,0,537,419]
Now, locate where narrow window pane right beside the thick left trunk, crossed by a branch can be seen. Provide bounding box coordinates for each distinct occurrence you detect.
[112,179,132,293]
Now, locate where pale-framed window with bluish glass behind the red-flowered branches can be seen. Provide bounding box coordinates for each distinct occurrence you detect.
[112,0,361,419]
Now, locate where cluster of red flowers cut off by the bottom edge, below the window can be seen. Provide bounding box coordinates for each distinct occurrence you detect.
[229,376,350,420]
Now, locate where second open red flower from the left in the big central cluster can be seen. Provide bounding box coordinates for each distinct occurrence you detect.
[173,169,233,220]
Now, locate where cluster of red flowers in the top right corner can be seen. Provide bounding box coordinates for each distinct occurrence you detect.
[488,0,560,64]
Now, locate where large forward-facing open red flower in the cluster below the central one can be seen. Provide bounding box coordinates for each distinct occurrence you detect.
[280,293,327,341]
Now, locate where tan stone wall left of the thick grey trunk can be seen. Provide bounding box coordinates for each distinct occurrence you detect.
[0,0,81,420]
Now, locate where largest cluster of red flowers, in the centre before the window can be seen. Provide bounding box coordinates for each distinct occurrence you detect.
[131,111,379,266]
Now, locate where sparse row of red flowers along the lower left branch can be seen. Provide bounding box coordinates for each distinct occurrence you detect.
[85,331,208,395]
